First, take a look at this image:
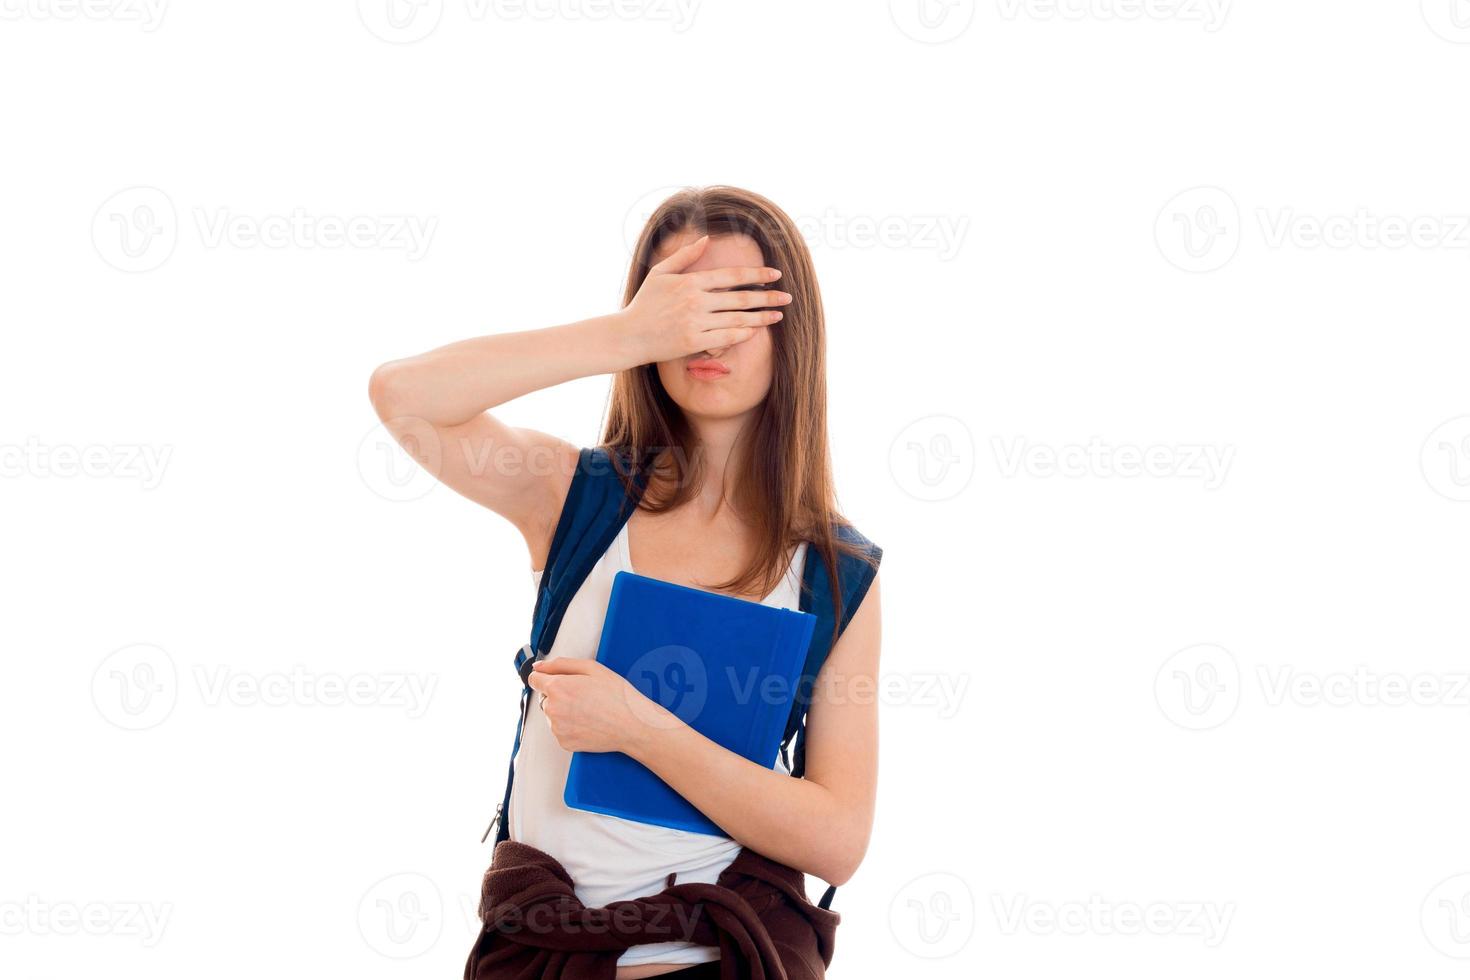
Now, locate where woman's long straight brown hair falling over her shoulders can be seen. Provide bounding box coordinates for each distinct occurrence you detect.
[603,187,870,623]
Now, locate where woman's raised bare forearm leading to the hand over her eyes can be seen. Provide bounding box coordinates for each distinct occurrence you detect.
[370,311,642,426]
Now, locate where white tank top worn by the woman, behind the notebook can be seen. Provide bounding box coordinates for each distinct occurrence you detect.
[510,525,807,967]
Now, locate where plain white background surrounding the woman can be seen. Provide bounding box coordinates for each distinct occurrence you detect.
[0,0,1470,980]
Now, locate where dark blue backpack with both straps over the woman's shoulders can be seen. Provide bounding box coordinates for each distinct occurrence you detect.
[481,447,883,908]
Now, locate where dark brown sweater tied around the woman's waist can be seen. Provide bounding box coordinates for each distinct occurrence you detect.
[465,840,841,980]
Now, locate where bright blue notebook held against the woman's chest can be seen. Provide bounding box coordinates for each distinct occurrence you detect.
[563,572,816,836]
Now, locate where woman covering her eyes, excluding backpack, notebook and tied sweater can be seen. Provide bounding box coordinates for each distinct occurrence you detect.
[370,187,881,980]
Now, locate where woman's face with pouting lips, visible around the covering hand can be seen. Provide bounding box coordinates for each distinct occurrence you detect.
[654,231,779,420]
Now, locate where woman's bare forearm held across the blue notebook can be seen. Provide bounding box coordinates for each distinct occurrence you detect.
[625,714,869,884]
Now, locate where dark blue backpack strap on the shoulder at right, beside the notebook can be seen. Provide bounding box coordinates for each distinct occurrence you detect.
[781,525,883,777]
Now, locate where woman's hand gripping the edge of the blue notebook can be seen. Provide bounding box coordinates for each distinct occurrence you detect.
[531,657,679,755]
